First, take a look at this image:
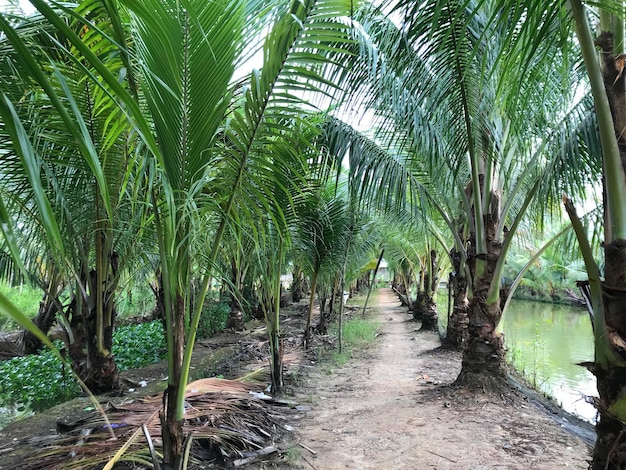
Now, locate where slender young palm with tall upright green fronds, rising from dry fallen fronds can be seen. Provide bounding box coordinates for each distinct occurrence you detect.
[3,0,360,464]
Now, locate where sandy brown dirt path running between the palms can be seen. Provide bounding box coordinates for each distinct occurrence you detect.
[296,289,589,470]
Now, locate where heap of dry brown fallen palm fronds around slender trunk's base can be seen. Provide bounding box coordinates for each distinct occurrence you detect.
[18,378,283,470]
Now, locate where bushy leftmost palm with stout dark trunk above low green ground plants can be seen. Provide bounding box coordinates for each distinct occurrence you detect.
[0,6,151,391]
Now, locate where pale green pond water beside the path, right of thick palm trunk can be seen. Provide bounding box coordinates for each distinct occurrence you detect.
[501,300,597,421]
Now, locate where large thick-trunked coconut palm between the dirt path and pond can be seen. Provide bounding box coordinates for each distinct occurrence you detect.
[330,2,592,383]
